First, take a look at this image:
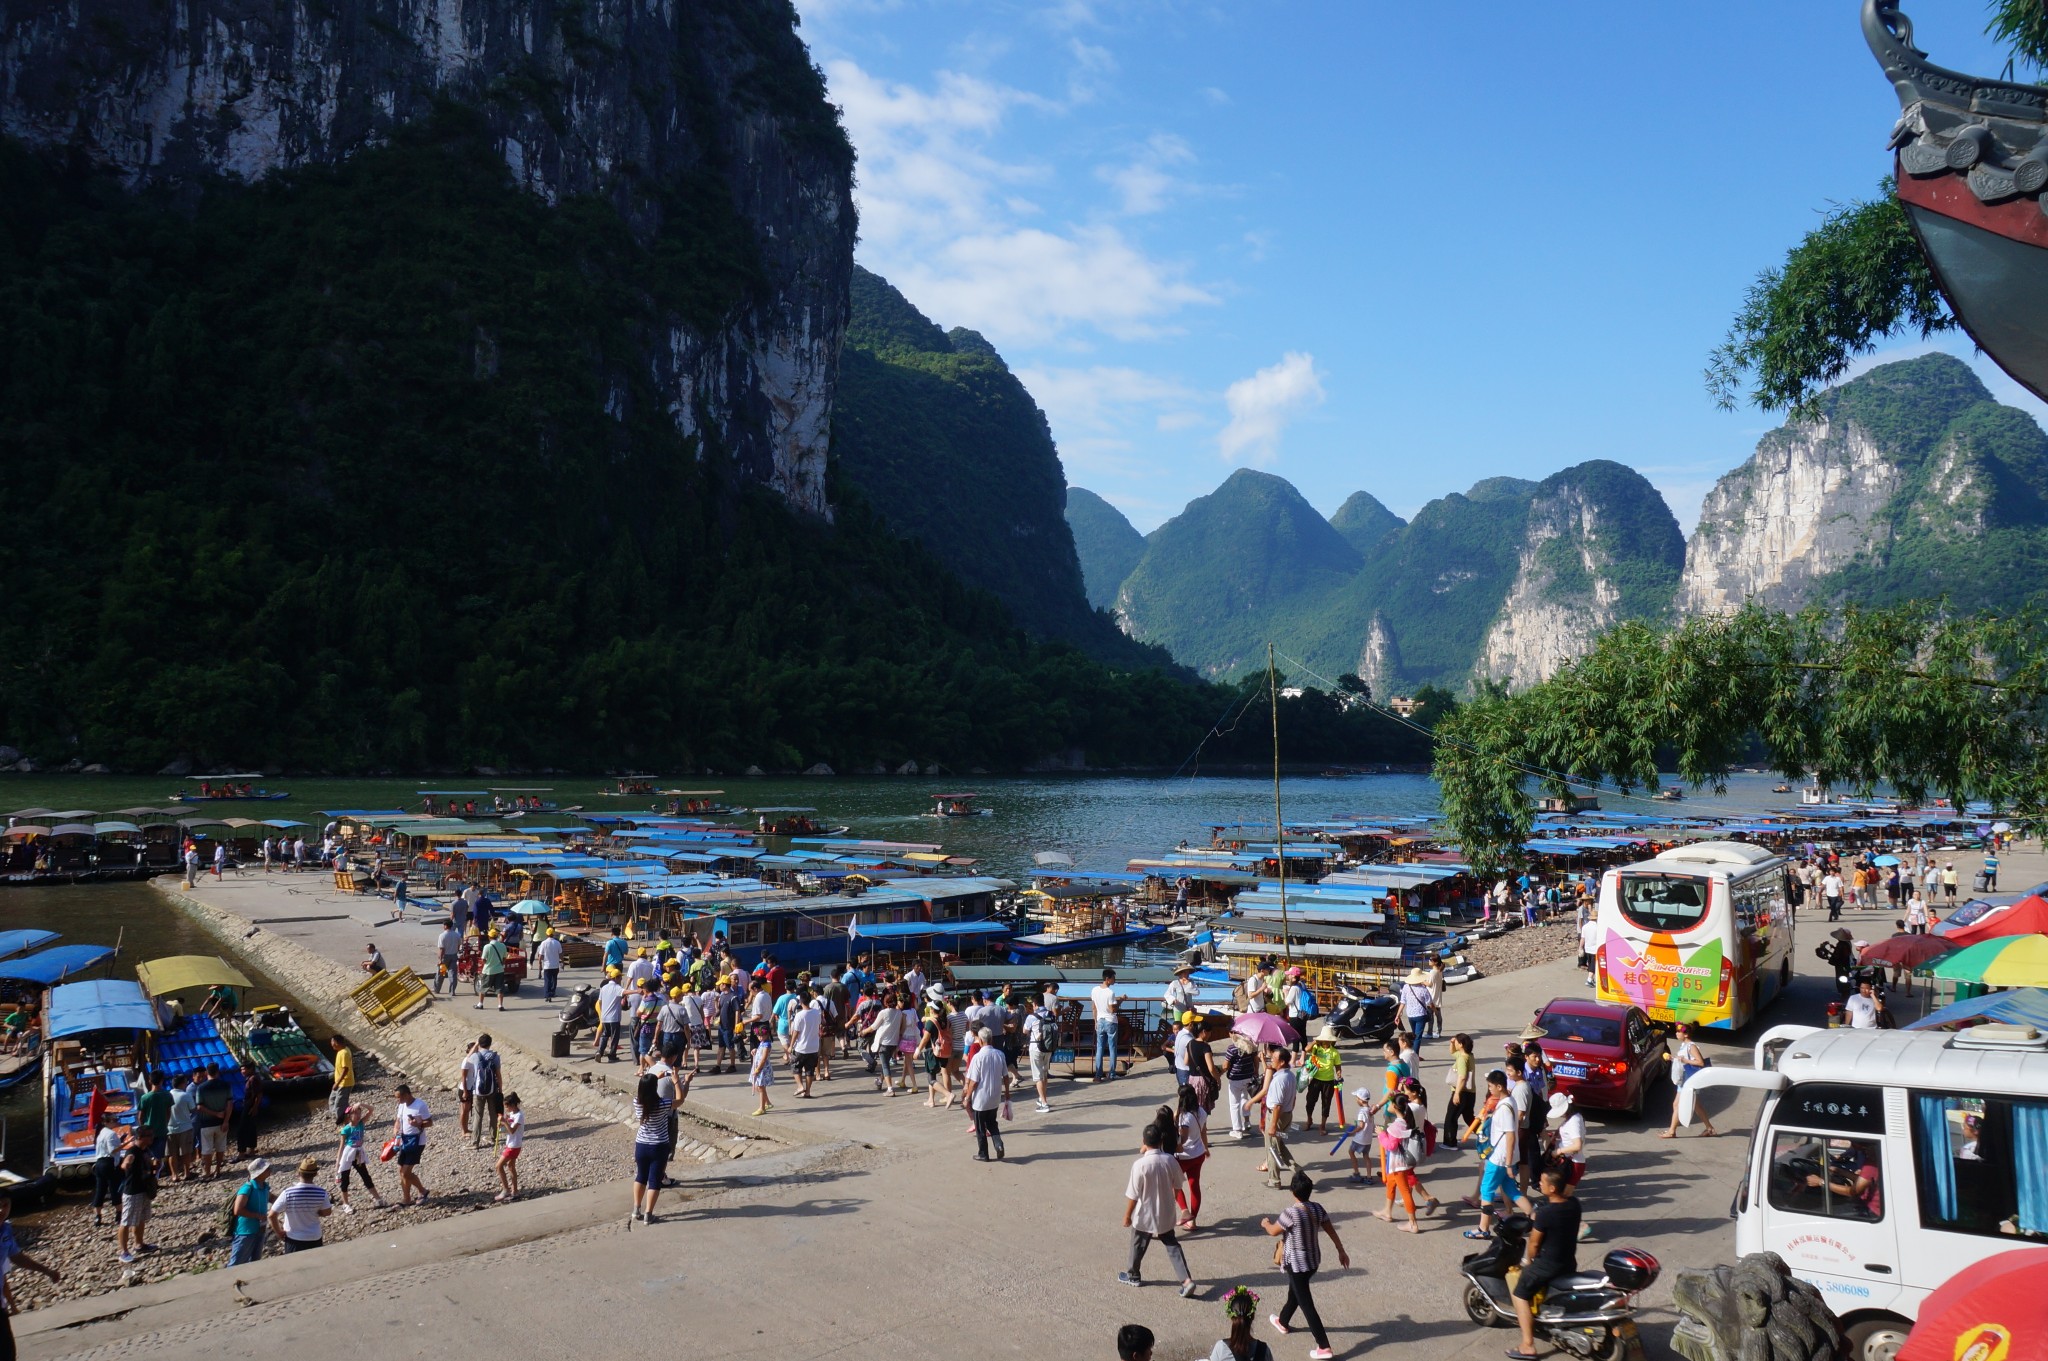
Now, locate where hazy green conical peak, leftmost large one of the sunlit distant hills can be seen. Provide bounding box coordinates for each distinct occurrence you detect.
[1116,469,1360,675]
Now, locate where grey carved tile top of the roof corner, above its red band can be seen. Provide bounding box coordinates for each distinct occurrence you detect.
[1864,0,2048,213]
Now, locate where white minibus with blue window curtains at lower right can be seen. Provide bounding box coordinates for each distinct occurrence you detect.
[1679,1025,2048,1361]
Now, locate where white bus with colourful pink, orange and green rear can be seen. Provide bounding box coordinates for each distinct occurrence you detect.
[1593,841,1792,1029]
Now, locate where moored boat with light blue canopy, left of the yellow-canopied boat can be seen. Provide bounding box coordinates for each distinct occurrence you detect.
[43,978,162,1177]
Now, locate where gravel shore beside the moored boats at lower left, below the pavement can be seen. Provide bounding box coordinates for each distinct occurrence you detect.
[8,1064,633,1308]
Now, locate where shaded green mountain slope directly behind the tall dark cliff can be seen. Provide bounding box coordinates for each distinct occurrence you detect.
[831,266,1171,665]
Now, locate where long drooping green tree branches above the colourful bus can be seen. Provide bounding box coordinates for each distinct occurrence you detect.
[1436,602,2048,872]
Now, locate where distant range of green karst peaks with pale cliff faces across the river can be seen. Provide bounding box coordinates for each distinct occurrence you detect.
[1069,354,2048,696]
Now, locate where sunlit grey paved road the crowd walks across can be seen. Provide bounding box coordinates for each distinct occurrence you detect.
[36,851,1998,1361]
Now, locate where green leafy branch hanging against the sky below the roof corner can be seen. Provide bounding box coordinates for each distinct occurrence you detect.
[1706,178,1956,418]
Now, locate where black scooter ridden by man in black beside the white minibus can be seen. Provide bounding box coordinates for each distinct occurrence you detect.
[1462,1214,1659,1361]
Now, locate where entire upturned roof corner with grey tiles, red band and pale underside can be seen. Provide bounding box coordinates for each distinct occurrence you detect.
[1864,0,2048,397]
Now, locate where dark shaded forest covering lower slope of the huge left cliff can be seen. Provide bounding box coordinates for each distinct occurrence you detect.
[0,127,1415,772]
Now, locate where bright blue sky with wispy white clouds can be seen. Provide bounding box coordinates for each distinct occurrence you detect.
[799,0,2044,530]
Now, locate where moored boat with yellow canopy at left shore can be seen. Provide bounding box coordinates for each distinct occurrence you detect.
[135,954,334,1101]
